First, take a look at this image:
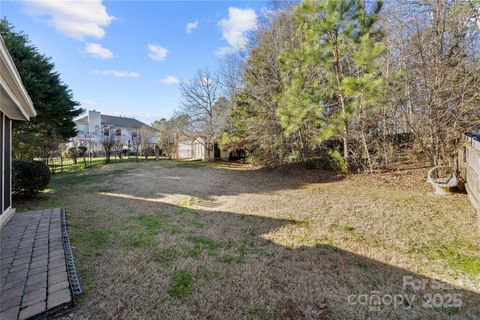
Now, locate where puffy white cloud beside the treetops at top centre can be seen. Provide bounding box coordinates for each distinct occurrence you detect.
[218,7,257,50]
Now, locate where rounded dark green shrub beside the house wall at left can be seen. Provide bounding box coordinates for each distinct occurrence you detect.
[12,160,50,197]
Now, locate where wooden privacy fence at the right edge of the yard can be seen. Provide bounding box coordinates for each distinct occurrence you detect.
[459,135,480,228]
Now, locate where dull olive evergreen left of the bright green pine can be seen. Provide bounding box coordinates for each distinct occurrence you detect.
[221,11,301,165]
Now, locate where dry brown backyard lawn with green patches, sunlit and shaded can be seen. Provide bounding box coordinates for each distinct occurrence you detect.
[17,161,480,319]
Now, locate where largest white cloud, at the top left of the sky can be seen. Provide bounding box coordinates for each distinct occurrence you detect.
[24,0,115,40]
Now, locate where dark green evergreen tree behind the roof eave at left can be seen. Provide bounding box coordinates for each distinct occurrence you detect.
[0,19,83,157]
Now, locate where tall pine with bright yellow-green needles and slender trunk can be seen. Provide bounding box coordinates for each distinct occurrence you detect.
[278,0,383,168]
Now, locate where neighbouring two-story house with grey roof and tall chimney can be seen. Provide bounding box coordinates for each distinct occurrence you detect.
[72,110,158,154]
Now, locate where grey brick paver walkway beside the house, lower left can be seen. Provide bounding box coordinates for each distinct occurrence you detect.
[0,209,72,320]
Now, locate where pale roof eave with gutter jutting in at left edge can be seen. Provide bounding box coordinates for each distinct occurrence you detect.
[0,36,37,120]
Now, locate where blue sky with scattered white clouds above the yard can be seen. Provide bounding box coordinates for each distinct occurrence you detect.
[1,0,268,123]
